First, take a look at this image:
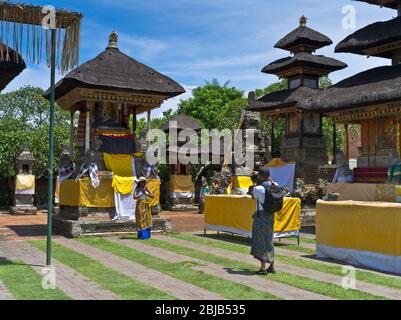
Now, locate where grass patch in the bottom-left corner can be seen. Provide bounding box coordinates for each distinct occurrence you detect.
[0,259,70,300]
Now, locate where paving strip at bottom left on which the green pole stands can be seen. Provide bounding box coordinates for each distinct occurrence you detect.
[0,241,120,300]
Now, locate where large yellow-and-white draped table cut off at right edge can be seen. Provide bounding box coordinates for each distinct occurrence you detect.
[316,201,401,274]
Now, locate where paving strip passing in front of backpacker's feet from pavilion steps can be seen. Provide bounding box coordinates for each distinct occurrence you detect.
[107,238,333,300]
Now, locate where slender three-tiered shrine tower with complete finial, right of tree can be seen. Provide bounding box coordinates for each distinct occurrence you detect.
[248,16,347,183]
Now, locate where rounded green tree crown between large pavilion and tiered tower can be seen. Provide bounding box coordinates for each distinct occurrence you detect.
[179,80,247,130]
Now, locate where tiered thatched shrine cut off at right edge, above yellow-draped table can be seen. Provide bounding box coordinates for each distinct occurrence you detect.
[308,0,401,179]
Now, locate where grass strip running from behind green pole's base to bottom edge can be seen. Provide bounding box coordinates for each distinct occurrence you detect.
[30,241,175,300]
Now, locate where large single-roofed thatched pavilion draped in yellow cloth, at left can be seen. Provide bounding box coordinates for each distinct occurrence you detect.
[46,32,185,235]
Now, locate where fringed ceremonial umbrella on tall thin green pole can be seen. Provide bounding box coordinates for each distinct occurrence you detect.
[0,1,82,265]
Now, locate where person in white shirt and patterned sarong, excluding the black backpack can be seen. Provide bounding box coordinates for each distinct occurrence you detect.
[250,168,277,275]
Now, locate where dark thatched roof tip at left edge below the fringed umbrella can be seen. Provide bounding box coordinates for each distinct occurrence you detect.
[0,44,26,91]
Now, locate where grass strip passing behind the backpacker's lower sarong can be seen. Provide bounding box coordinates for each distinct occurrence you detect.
[171,233,401,289]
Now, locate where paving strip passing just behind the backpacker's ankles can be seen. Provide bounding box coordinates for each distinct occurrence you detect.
[154,236,401,300]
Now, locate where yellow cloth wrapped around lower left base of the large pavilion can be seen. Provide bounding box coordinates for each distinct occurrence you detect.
[60,178,115,208]
